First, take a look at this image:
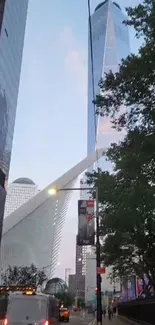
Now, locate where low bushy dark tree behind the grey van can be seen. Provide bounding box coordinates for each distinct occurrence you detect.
[1,264,47,286]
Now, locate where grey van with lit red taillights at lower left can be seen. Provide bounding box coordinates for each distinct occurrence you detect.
[1,288,60,325]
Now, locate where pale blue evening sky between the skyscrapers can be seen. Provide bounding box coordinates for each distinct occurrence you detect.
[9,0,140,276]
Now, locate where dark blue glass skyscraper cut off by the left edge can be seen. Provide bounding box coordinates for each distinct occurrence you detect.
[0,0,28,241]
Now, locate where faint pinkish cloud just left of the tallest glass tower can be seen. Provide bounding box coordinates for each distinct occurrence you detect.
[60,27,87,95]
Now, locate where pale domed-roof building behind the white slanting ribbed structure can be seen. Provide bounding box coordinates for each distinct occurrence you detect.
[4,177,39,217]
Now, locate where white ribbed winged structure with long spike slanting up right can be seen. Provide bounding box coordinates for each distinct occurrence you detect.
[1,149,103,278]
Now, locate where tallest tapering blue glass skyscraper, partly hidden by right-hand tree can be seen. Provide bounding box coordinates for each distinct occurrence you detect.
[87,0,130,154]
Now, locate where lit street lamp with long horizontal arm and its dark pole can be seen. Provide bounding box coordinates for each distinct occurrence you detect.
[48,187,102,325]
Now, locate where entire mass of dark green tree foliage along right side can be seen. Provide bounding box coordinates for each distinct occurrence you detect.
[87,0,155,293]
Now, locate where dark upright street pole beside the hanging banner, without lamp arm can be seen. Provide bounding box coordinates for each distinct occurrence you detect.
[96,187,102,325]
